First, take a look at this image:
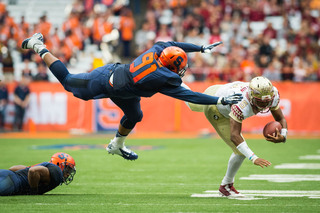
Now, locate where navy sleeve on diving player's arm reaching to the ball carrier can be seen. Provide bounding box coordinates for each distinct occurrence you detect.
[159,86,219,105]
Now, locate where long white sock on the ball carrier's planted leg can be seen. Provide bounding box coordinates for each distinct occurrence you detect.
[221,153,246,185]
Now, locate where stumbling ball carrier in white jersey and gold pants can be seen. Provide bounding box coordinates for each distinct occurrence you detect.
[183,77,287,196]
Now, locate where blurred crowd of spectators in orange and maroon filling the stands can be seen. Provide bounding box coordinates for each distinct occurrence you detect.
[0,0,320,85]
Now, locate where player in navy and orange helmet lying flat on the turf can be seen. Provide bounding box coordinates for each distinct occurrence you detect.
[0,152,76,196]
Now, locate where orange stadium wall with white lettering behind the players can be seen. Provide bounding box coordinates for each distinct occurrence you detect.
[6,82,320,134]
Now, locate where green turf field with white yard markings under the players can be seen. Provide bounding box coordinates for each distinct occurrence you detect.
[0,137,320,213]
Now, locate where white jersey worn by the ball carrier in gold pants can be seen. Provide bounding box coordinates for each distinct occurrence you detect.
[215,81,280,123]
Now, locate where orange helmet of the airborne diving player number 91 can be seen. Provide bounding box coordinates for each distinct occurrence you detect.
[159,46,188,77]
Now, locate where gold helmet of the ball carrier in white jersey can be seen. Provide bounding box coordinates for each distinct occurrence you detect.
[249,76,275,112]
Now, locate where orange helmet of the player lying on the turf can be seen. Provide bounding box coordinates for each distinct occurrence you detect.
[49,152,76,185]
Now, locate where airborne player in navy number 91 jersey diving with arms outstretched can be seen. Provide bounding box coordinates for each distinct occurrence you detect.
[22,33,242,160]
